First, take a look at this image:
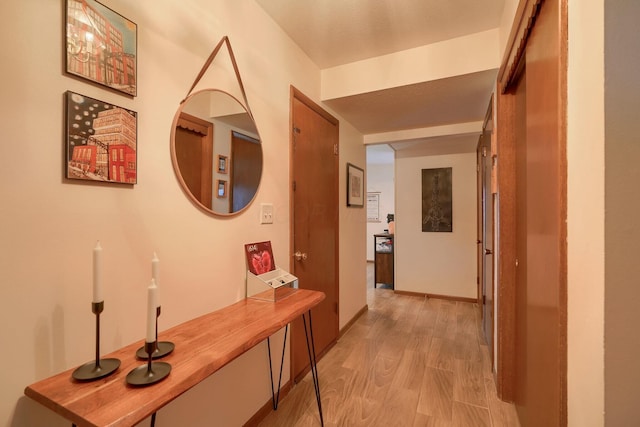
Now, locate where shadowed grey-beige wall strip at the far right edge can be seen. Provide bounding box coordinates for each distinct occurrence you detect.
[592,0,640,426]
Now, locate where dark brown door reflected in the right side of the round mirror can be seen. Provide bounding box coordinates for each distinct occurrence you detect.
[229,132,262,212]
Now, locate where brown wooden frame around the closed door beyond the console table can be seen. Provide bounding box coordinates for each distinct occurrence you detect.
[289,85,340,381]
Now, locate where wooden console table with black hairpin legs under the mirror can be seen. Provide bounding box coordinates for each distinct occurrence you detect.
[24,289,325,426]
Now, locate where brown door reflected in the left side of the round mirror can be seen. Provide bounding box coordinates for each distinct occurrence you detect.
[175,113,213,209]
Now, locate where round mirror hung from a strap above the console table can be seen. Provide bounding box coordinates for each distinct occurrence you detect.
[171,89,262,215]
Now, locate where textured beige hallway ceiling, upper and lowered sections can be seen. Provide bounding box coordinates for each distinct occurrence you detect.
[256,0,505,155]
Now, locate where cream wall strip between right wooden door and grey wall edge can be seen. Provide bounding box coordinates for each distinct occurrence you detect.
[567,0,605,427]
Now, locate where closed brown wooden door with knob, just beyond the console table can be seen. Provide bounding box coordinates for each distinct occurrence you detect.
[291,89,339,380]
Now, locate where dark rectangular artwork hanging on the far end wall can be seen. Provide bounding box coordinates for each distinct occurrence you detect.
[422,168,453,232]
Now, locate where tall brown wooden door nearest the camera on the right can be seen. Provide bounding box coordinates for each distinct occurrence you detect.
[516,0,567,427]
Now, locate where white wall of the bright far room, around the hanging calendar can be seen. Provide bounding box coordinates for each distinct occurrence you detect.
[367,162,395,261]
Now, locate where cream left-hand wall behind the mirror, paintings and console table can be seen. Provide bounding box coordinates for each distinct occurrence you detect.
[0,0,366,426]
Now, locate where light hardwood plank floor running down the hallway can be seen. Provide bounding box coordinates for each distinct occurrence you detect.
[260,266,519,427]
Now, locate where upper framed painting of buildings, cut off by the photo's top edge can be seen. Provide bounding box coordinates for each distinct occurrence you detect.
[65,0,138,96]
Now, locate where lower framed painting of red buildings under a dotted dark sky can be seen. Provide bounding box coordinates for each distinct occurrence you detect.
[65,91,138,184]
